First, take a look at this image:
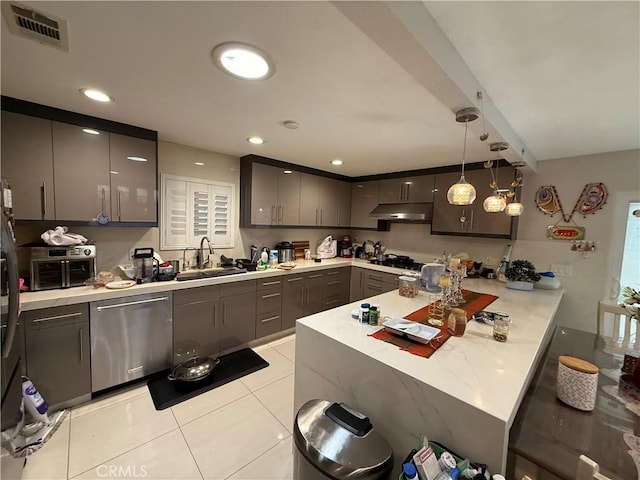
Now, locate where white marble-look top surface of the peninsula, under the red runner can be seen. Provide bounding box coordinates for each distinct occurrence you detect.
[298,279,563,426]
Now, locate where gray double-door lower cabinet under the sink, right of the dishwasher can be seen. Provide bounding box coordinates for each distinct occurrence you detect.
[173,280,256,363]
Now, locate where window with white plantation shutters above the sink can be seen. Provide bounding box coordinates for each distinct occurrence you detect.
[160,174,234,250]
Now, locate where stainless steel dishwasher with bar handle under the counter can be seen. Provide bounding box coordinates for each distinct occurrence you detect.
[89,292,173,392]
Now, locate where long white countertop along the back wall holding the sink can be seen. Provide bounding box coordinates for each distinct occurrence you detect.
[0,258,416,312]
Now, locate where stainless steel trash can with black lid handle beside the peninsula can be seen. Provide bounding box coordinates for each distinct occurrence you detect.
[293,400,393,480]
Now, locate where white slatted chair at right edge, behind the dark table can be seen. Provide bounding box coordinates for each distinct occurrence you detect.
[598,302,640,355]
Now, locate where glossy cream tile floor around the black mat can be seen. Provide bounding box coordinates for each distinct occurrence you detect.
[22,335,295,480]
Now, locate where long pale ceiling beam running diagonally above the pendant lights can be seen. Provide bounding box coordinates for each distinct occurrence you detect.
[332,1,537,171]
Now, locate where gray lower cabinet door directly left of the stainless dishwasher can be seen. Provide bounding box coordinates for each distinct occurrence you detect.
[21,303,91,407]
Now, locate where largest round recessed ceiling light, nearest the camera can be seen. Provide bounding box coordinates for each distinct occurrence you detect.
[211,42,275,80]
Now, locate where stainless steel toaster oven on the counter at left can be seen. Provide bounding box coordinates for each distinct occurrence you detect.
[30,245,96,291]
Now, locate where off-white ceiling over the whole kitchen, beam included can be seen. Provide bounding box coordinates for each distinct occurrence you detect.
[1,1,640,175]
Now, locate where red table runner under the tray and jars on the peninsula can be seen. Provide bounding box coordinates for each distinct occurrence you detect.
[369,290,498,358]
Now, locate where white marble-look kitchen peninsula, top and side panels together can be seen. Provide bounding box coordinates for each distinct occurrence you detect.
[294,279,563,476]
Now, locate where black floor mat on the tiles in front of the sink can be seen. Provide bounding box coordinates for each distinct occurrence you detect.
[147,348,269,410]
